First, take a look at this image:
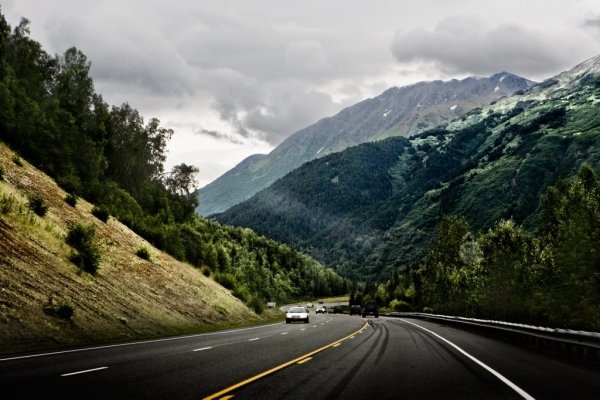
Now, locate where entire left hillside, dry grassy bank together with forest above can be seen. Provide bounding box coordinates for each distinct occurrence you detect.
[0,7,347,350]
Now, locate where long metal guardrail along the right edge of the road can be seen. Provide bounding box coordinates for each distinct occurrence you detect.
[385,312,600,362]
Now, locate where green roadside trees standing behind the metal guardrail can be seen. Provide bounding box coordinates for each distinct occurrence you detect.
[366,166,600,331]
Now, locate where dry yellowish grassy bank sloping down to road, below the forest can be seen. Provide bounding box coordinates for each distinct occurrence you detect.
[0,143,259,352]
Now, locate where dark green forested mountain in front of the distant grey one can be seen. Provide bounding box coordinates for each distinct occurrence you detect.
[216,57,600,278]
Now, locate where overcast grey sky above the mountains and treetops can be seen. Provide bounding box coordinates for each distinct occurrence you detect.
[0,0,600,186]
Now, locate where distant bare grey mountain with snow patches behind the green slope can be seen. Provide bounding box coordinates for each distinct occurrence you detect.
[196,72,533,215]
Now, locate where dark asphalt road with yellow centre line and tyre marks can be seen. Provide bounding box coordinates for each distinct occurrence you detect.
[0,314,600,400]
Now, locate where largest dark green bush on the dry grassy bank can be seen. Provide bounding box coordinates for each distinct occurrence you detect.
[66,224,100,274]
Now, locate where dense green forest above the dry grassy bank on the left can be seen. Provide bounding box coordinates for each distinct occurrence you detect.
[0,8,347,311]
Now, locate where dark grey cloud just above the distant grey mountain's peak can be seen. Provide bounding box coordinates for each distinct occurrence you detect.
[391,16,579,76]
